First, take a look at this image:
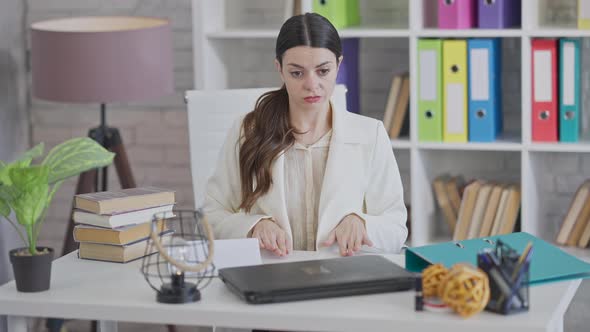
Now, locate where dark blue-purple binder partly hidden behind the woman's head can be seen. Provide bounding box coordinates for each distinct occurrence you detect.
[336,38,361,114]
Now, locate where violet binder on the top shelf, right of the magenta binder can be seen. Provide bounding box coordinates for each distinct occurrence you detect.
[477,0,521,29]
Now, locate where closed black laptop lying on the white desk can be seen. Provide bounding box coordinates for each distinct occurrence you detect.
[219,255,413,294]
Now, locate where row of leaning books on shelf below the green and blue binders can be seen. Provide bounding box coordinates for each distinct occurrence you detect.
[433,175,520,241]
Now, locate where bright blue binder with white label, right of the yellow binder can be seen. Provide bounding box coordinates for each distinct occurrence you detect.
[467,38,502,142]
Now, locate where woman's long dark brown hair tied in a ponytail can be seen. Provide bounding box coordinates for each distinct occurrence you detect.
[239,13,342,212]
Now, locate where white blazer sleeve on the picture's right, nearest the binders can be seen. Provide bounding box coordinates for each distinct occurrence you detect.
[356,121,408,253]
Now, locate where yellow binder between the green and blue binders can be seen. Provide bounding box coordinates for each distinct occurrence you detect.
[443,40,467,142]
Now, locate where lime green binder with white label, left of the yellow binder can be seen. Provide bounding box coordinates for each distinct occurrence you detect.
[418,39,443,142]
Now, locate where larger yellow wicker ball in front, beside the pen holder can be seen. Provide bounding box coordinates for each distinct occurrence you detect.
[438,264,490,318]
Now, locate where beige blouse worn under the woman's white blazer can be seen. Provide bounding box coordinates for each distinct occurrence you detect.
[285,130,332,250]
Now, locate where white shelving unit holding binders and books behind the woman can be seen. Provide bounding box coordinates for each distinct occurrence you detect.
[193,0,590,259]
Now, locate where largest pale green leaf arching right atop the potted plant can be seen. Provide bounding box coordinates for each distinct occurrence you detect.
[43,137,115,184]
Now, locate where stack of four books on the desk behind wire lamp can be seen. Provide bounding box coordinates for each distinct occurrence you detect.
[73,187,175,263]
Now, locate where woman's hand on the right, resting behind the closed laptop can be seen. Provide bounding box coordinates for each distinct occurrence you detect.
[324,214,373,256]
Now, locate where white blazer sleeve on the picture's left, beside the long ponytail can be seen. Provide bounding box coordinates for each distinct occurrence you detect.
[203,117,270,239]
